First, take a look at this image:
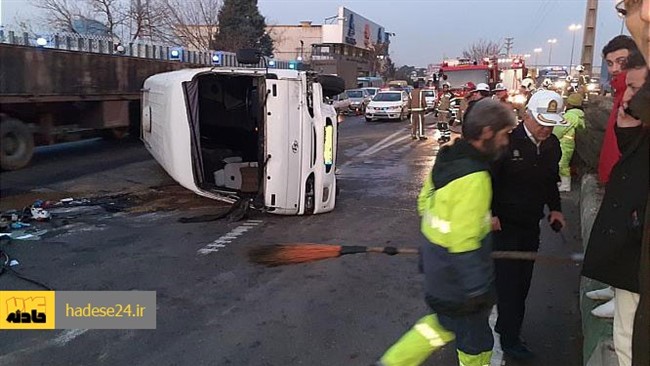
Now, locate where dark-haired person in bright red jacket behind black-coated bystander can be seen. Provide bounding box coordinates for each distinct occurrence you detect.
[598,35,637,184]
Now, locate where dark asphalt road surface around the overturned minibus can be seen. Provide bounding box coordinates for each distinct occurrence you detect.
[0,117,582,366]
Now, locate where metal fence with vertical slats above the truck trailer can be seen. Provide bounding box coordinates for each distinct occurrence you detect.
[0,29,292,69]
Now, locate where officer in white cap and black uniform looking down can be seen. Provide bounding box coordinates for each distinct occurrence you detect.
[491,90,567,359]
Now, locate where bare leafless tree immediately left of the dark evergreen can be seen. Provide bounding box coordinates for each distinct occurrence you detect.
[161,0,221,51]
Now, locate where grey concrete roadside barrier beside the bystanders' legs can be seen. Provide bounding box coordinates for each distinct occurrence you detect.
[580,174,618,366]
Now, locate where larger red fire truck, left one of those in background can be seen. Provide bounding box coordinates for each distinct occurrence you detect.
[438,58,499,96]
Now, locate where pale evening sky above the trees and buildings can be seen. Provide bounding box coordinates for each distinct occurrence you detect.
[0,0,628,67]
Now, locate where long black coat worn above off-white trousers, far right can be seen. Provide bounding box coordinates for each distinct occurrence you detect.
[582,126,650,293]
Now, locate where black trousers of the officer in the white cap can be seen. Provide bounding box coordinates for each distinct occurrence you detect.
[493,220,539,347]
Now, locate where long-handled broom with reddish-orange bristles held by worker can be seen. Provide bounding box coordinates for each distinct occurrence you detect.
[248,243,583,267]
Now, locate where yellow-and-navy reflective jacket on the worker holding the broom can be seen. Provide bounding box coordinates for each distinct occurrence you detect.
[418,139,493,313]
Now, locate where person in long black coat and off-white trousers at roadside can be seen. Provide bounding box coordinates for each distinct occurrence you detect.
[582,47,650,366]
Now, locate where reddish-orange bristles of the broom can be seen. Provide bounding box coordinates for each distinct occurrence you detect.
[248,244,341,267]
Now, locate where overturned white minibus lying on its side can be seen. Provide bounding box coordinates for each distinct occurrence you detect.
[141,53,344,215]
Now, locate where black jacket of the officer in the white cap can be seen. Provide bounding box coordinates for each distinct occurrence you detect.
[491,123,562,226]
